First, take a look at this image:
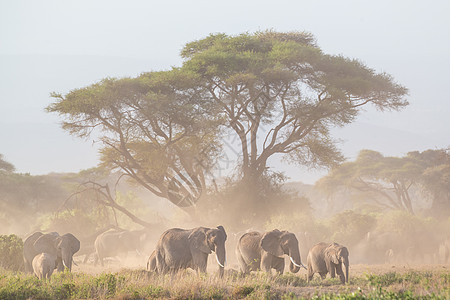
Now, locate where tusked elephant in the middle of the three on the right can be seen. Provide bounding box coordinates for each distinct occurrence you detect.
[236,229,306,274]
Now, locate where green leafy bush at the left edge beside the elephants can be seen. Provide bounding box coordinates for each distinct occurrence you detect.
[0,234,23,271]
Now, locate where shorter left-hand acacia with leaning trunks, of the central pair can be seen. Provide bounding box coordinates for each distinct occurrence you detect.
[47,69,220,207]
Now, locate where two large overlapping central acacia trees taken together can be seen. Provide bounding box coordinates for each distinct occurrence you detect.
[47,31,408,211]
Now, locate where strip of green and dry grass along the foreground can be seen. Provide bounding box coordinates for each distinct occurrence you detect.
[0,269,450,299]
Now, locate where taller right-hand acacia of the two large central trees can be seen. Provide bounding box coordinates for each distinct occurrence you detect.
[182,31,408,201]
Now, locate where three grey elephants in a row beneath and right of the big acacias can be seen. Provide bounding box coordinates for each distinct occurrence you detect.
[147,226,349,283]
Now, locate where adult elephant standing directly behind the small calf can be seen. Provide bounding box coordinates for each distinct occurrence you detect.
[23,232,80,272]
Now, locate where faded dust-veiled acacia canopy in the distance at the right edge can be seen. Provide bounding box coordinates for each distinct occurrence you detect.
[316,150,450,214]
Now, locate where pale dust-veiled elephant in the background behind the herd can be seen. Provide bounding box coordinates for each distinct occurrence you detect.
[94,229,141,266]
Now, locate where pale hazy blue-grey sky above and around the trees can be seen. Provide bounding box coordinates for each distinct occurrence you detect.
[0,0,450,183]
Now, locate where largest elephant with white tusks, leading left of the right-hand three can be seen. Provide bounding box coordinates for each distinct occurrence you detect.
[155,226,227,277]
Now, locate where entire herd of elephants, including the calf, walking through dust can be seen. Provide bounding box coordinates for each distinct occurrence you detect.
[23,226,349,283]
